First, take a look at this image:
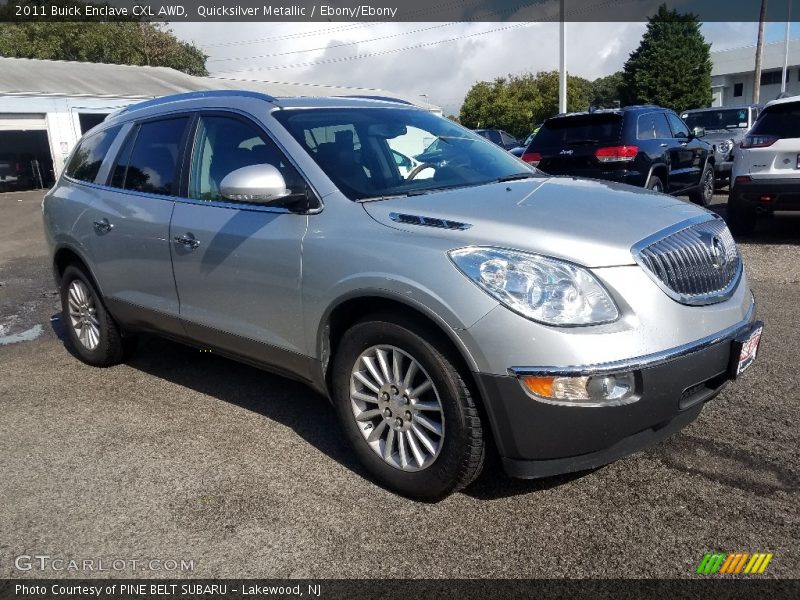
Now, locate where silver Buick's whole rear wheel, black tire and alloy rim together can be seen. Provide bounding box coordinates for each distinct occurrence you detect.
[61,265,136,367]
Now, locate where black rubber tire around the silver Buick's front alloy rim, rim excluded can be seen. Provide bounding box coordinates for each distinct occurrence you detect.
[332,315,486,501]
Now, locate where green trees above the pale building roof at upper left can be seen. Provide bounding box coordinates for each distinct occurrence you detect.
[0,2,208,75]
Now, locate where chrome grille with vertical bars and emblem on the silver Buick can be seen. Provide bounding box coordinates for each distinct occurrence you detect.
[633,218,742,305]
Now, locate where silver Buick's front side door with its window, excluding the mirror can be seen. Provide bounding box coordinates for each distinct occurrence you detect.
[170,113,308,372]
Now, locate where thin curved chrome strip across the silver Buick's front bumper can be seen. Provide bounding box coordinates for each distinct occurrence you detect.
[508,296,756,377]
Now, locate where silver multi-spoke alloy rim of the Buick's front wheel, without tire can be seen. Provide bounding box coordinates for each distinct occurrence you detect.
[350,345,445,471]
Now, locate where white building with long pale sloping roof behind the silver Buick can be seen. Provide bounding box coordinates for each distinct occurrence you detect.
[0,57,441,186]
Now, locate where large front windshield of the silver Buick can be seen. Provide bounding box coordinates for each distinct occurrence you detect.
[273,108,538,200]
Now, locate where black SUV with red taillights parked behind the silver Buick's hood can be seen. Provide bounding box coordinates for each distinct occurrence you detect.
[522,106,714,206]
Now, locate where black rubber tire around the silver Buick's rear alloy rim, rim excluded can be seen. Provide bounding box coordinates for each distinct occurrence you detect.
[60,265,136,367]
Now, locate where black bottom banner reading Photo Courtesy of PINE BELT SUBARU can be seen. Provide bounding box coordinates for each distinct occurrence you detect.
[0,575,800,600]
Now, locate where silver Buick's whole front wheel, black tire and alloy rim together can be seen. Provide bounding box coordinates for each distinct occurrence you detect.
[333,316,485,500]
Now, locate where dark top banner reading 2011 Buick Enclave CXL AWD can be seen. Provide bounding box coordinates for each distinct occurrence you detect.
[0,0,800,22]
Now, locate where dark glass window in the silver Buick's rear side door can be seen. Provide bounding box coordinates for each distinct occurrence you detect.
[111,117,189,195]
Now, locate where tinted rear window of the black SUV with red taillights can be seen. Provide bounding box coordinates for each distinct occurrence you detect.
[531,113,622,150]
